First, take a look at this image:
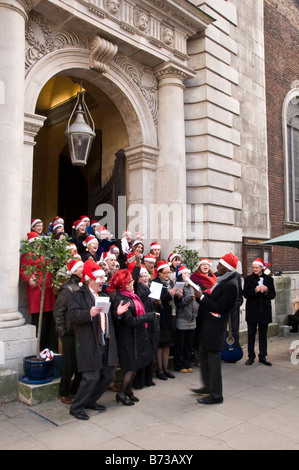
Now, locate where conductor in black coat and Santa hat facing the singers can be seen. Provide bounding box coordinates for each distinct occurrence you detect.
[193,253,239,405]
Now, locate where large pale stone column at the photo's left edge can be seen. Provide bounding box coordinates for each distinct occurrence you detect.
[0,0,34,374]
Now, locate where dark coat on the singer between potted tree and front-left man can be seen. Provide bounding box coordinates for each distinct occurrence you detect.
[53,274,80,337]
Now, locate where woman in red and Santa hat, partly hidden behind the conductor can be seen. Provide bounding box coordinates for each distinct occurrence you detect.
[190,258,217,366]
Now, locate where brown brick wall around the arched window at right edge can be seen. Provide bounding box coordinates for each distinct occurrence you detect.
[264,0,299,271]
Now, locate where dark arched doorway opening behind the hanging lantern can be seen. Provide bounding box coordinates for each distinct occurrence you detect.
[32,75,128,234]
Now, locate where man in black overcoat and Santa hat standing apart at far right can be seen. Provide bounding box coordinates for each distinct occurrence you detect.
[243,258,275,366]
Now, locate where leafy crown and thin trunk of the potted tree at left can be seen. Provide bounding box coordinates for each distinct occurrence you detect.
[20,234,71,358]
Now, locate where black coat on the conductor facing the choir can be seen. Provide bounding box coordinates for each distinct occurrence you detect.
[199,272,239,351]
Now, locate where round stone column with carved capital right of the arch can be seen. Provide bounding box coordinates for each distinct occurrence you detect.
[155,62,194,253]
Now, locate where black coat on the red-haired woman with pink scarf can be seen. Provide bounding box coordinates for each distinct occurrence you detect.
[114,292,155,370]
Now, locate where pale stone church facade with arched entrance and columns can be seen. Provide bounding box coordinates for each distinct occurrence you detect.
[0,0,299,380]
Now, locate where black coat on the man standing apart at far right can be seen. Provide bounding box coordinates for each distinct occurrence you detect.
[243,273,275,323]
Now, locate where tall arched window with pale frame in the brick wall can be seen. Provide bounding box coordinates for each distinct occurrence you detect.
[283,82,299,223]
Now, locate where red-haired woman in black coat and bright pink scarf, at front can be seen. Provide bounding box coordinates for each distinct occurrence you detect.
[106,269,156,406]
